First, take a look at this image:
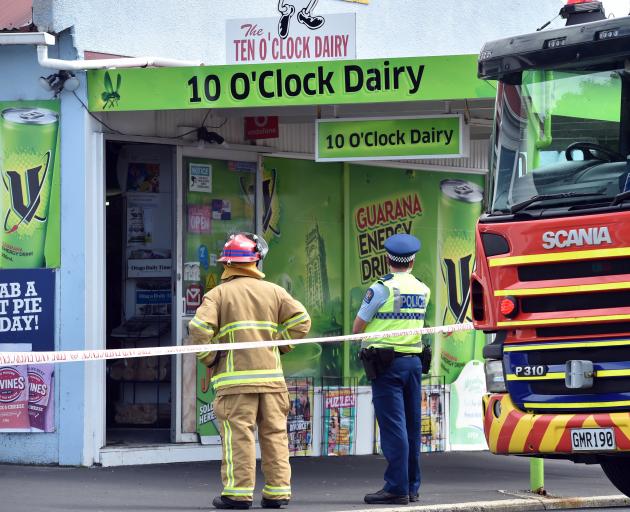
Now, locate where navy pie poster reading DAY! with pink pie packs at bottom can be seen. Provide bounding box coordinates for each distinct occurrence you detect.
[0,269,55,432]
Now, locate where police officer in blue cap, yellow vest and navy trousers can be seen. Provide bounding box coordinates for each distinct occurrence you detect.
[352,234,430,505]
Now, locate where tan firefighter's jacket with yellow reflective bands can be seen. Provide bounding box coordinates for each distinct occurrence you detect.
[189,275,311,396]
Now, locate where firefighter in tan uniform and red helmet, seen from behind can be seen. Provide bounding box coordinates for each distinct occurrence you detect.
[189,233,311,509]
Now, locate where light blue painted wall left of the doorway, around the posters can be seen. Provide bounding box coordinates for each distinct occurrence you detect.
[0,33,90,465]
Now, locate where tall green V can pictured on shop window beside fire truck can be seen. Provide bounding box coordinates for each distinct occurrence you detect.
[432,179,483,384]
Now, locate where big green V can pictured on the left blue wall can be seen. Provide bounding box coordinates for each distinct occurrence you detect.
[0,108,59,268]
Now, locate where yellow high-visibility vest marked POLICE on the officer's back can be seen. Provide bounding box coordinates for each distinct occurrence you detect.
[363,272,431,354]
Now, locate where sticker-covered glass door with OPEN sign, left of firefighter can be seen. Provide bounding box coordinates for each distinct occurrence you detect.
[176,149,258,444]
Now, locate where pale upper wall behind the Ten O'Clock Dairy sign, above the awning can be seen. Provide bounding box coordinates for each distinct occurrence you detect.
[33,0,568,64]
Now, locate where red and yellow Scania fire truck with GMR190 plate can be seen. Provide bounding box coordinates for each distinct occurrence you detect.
[470,0,630,496]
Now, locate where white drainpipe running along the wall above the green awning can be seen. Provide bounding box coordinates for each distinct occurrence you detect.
[0,32,203,71]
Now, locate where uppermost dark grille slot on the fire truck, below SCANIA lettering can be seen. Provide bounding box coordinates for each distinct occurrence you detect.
[518,257,630,281]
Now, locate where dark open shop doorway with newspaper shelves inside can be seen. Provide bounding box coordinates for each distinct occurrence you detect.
[105,141,175,446]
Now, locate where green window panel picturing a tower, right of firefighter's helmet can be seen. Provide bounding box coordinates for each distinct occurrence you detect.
[258,158,343,378]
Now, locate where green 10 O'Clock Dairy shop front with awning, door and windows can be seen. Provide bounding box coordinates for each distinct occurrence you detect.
[88,55,495,465]
